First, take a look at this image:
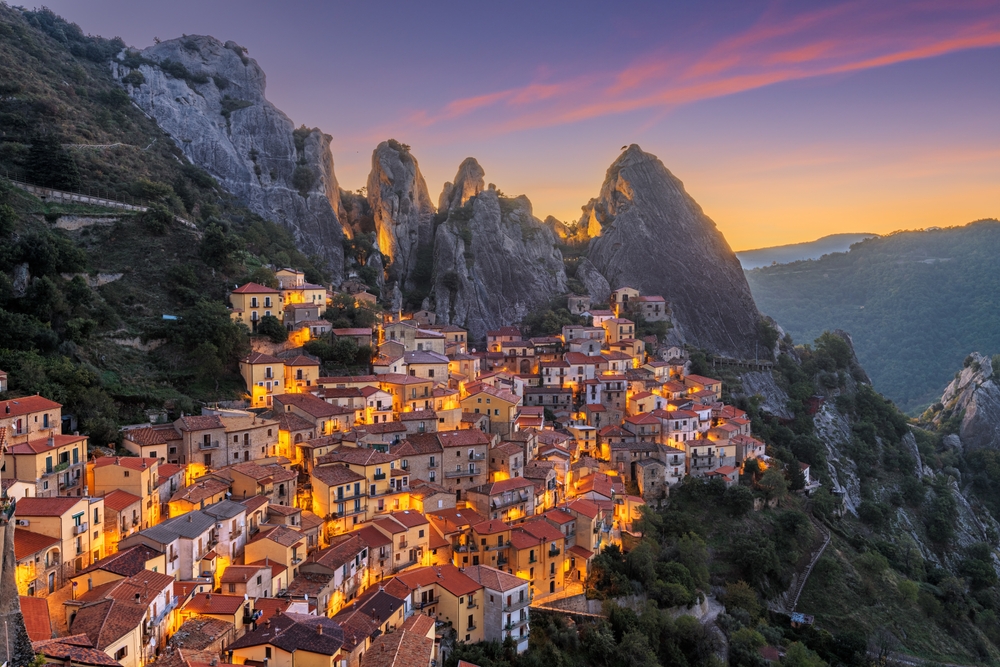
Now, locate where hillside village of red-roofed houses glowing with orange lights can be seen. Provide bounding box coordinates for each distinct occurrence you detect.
[0,269,796,667]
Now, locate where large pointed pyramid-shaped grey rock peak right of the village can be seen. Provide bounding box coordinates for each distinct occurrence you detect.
[578,144,769,358]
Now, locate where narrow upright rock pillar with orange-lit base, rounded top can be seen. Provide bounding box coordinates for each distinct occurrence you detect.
[368,139,435,290]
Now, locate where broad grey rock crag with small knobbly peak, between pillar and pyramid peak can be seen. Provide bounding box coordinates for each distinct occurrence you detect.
[434,158,566,341]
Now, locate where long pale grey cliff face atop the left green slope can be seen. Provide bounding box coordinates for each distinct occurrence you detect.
[112,35,344,278]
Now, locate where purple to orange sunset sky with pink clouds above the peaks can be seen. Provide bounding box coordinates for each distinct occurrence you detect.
[37,0,1000,250]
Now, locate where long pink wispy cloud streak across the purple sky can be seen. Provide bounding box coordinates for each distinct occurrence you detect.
[390,0,1000,140]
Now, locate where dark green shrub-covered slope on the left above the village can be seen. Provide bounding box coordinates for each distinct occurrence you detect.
[0,5,324,444]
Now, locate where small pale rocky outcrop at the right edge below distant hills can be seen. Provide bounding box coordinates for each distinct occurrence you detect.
[933,352,1000,449]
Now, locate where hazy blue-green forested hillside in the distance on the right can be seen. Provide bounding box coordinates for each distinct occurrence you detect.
[747,220,1000,414]
